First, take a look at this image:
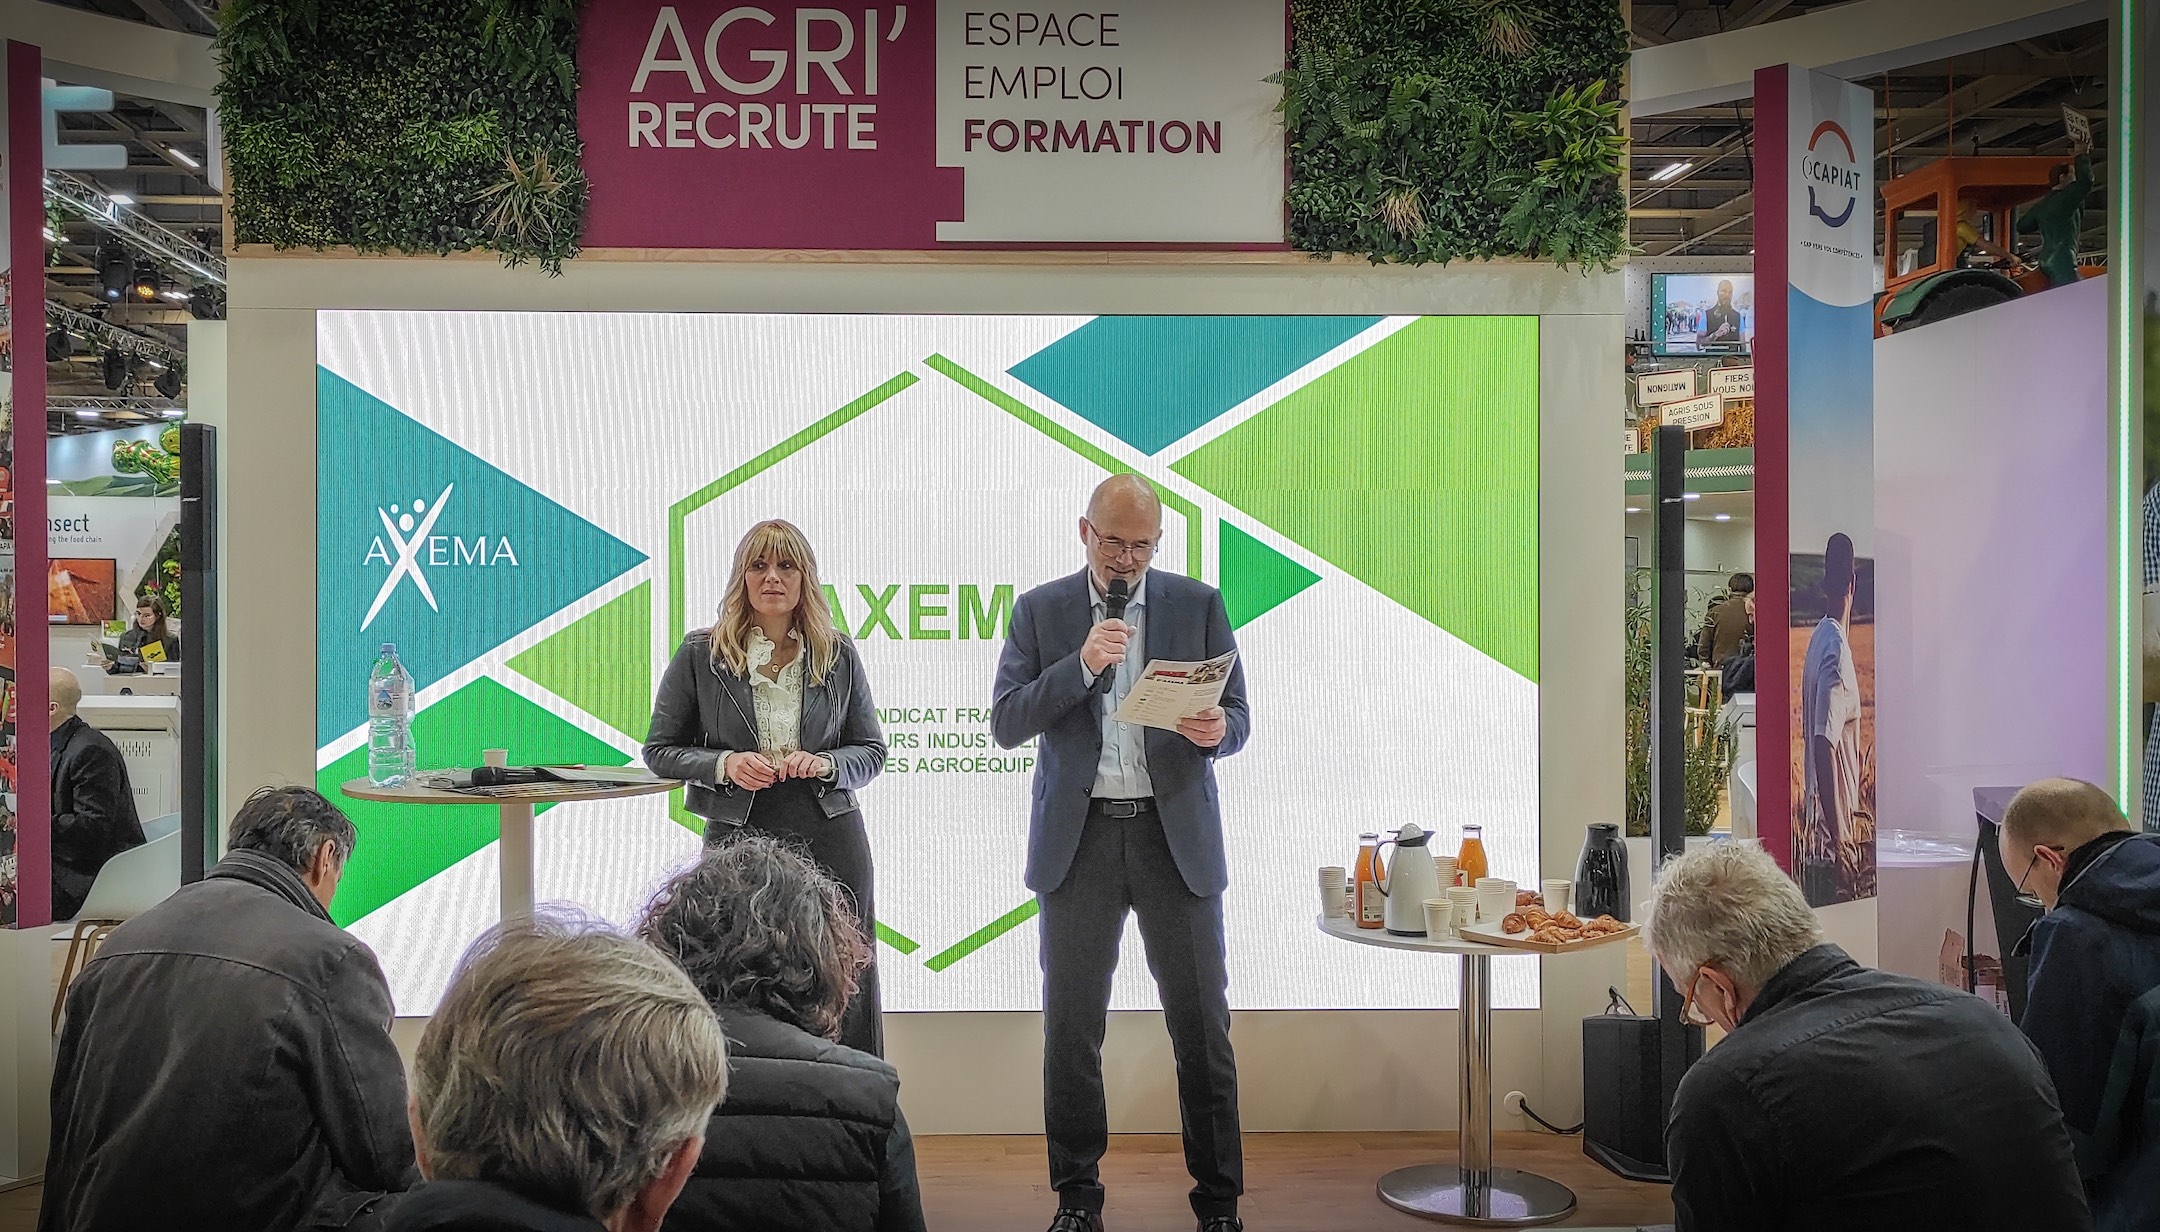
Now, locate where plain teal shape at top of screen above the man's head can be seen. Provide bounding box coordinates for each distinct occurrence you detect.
[1011,316,1380,454]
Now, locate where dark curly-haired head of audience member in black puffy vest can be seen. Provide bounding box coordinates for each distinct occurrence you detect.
[639,836,870,1040]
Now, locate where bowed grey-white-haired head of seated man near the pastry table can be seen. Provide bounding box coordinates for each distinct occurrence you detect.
[1644,841,1823,1031]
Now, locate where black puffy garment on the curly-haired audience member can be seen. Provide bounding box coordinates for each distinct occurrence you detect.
[661,1007,922,1232]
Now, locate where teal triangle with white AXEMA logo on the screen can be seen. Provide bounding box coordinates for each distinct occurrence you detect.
[315,367,646,739]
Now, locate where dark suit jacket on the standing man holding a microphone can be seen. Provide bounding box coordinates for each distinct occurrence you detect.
[989,571,1251,897]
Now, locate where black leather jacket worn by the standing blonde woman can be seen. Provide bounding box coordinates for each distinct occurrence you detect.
[646,629,886,826]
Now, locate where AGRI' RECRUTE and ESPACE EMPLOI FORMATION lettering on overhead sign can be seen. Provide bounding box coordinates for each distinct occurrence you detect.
[629,4,1223,153]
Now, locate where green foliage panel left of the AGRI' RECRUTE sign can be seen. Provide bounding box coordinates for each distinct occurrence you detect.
[218,0,585,272]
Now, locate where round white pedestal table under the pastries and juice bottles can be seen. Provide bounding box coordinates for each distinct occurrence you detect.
[1320,916,1575,1228]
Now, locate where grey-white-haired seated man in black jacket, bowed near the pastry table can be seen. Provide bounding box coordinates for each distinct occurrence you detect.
[1644,843,2091,1232]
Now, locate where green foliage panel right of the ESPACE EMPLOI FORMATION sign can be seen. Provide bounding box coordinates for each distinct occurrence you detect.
[1272,0,1629,268]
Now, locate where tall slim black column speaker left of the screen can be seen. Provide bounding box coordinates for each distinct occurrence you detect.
[179,424,220,882]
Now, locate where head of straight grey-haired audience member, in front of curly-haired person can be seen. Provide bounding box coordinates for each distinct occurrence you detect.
[413,916,728,1232]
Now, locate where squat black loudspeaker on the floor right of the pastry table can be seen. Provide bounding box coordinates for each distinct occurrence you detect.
[1583,1014,1702,1182]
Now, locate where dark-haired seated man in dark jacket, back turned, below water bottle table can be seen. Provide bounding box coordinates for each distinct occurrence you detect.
[37,787,417,1232]
